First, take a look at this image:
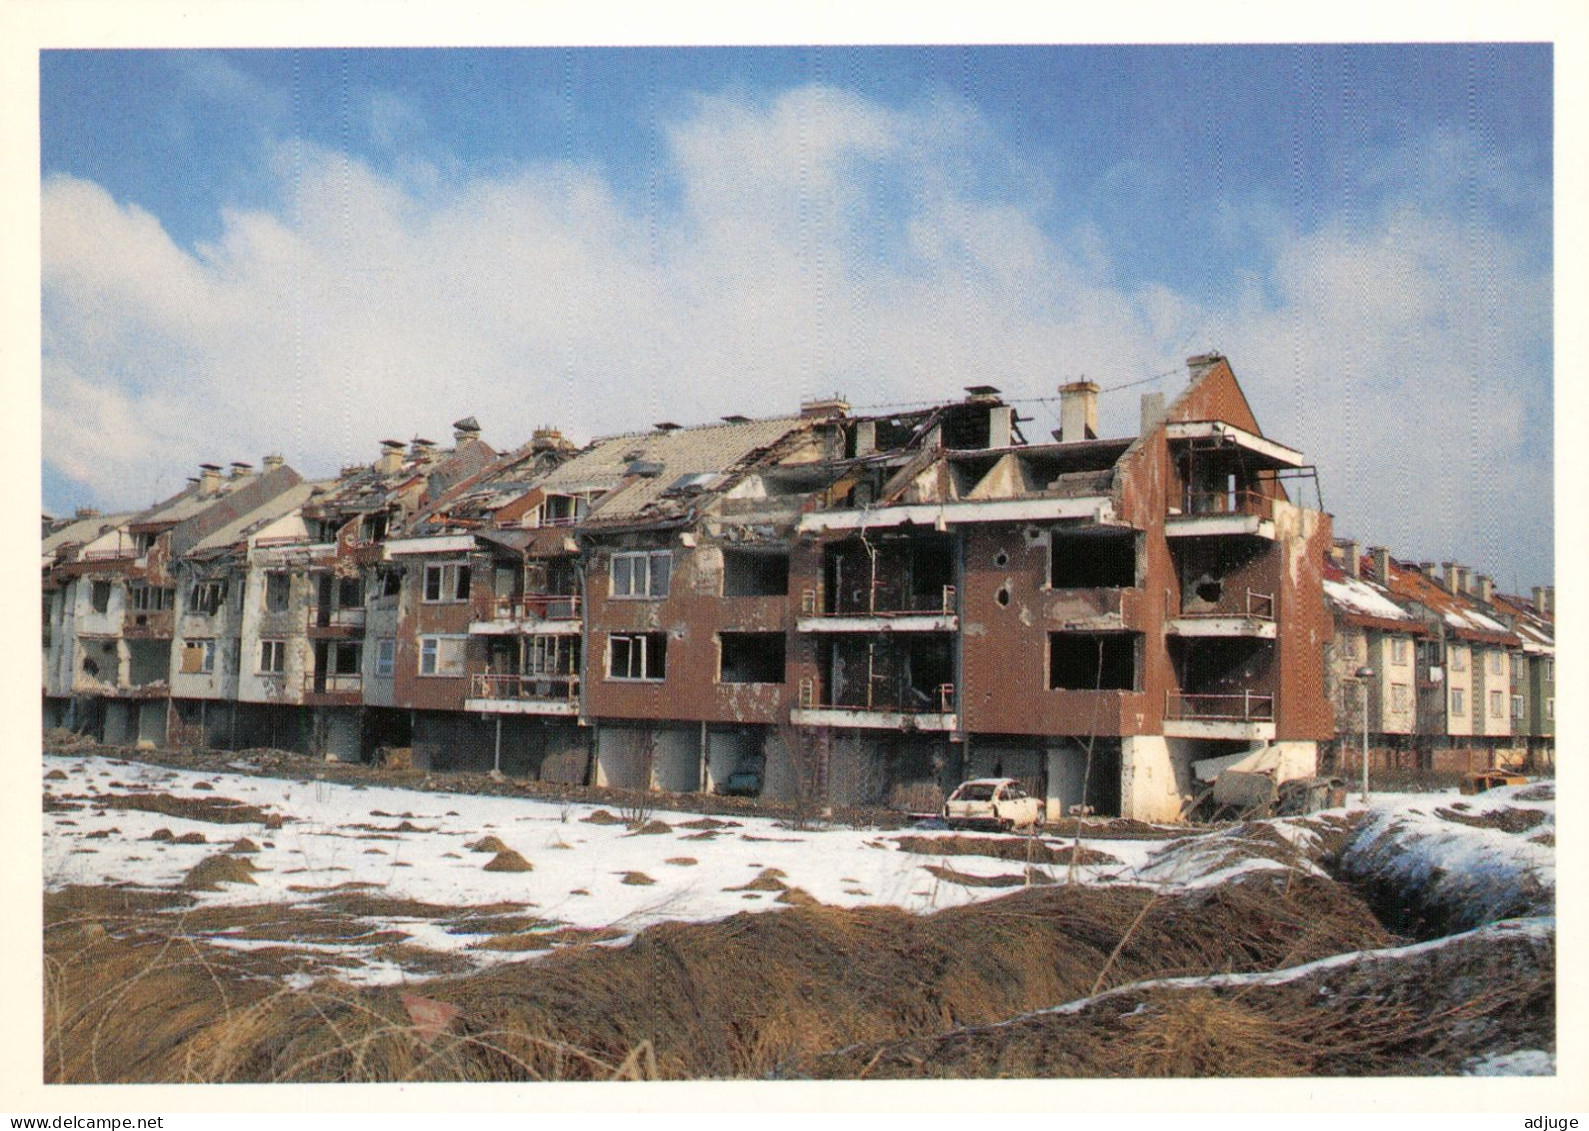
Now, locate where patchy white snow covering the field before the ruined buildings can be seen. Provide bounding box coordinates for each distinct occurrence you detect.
[43,755,1554,982]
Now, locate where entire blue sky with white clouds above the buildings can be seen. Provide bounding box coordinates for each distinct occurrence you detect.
[40,44,1552,586]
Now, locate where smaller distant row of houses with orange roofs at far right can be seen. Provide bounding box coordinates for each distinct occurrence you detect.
[1324,540,1556,770]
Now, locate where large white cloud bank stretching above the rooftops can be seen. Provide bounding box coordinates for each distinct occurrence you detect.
[43,87,1548,584]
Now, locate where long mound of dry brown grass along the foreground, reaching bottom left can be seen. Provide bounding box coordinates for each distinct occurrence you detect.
[46,877,1387,1082]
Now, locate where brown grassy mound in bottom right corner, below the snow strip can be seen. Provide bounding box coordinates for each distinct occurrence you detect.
[785,926,1556,1079]
